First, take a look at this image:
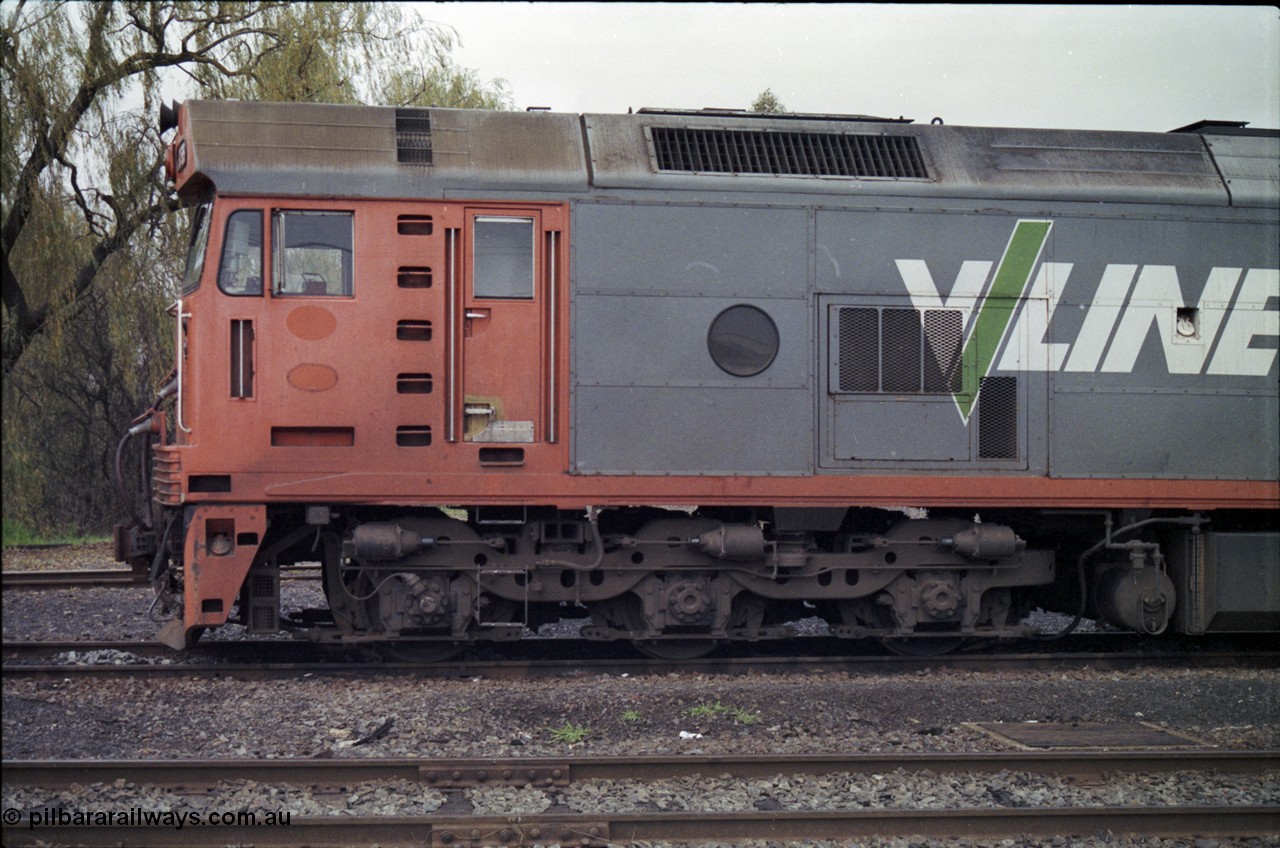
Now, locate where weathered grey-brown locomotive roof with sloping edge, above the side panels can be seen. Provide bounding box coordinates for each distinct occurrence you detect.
[174,101,1280,208]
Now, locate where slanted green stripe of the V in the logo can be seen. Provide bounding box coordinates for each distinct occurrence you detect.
[954,220,1053,421]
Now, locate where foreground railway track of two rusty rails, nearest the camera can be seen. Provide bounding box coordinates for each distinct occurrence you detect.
[4,751,1280,848]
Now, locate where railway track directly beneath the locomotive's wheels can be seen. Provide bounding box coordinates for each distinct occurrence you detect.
[3,639,1280,680]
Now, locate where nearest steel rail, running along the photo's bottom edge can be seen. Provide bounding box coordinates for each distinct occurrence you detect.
[4,806,1280,848]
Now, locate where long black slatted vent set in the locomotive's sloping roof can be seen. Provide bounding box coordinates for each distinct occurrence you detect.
[650,127,929,179]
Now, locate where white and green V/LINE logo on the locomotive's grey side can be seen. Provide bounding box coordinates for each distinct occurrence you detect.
[897,220,1280,421]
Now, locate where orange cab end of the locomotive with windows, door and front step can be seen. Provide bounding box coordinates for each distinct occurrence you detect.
[122,106,567,647]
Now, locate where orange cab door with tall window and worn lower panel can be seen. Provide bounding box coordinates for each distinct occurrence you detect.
[454,206,561,459]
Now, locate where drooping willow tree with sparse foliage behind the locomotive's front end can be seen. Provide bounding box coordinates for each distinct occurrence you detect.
[0,0,508,528]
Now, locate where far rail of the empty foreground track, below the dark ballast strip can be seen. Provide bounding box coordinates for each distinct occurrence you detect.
[3,748,1280,789]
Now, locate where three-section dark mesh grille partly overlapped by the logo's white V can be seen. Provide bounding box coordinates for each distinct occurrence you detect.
[837,307,964,395]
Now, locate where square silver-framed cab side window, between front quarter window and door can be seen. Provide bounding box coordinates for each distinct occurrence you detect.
[271,210,355,297]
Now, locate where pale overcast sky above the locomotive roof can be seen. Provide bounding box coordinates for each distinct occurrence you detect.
[412,3,1280,132]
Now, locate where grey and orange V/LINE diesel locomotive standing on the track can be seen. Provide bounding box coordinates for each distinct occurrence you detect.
[116,101,1280,657]
